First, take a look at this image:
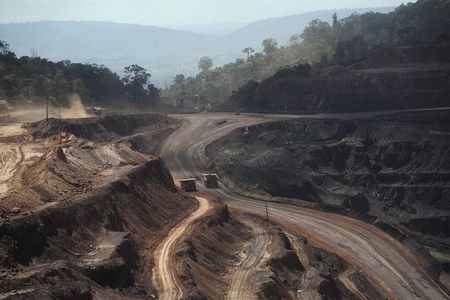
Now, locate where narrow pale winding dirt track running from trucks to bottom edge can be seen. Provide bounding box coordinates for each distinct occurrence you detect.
[153,197,211,300]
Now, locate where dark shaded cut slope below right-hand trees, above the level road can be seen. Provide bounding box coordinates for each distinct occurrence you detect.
[225,44,450,113]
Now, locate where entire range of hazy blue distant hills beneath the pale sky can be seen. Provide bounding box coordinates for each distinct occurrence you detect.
[0,8,393,87]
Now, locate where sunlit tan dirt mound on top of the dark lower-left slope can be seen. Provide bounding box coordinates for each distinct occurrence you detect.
[0,139,148,215]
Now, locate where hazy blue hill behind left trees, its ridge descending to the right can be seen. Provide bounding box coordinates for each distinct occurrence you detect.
[0,21,240,86]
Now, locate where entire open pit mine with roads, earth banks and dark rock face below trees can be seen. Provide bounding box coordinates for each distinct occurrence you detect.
[0,109,450,299]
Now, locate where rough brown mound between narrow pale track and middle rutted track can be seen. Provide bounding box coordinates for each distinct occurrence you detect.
[173,200,251,299]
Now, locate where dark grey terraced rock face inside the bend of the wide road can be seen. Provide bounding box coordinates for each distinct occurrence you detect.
[206,111,450,238]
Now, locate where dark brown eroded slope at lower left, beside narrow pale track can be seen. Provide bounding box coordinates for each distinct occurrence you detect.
[0,159,195,299]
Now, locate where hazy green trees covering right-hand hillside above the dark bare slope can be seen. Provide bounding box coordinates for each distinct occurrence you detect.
[164,0,450,101]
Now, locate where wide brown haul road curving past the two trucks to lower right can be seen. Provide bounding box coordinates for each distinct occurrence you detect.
[162,114,448,299]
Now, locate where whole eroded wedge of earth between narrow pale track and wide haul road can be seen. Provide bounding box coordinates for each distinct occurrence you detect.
[172,201,372,299]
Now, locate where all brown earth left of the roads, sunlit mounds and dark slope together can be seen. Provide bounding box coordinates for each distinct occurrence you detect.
[0,115,197,299]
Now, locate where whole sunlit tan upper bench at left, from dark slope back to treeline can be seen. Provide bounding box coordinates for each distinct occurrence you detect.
[0,114,183,216]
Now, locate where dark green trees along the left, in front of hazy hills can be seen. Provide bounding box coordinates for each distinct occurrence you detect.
[0,41,159,108]
